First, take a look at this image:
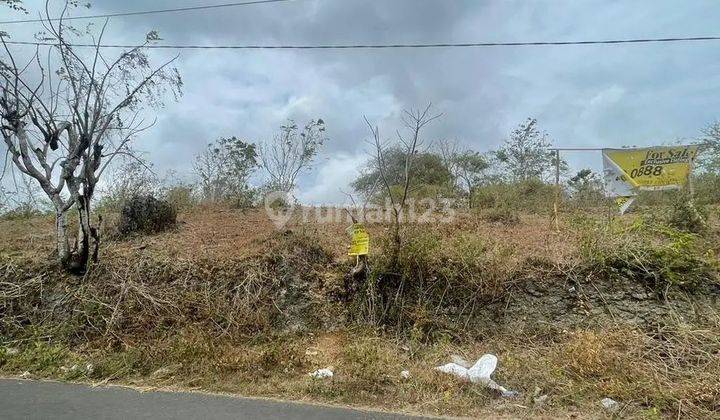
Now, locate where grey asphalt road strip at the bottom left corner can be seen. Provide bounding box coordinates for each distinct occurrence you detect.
[0,379,428,420]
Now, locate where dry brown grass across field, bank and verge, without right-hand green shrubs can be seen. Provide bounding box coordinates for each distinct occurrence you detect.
[0,208,720,418]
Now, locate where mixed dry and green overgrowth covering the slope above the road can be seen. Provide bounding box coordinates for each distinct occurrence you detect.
[0,213,720,417]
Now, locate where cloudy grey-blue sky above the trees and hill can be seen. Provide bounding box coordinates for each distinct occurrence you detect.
[0,0,720,204]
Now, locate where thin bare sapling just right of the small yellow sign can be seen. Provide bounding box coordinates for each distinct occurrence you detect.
[363,104,442,265]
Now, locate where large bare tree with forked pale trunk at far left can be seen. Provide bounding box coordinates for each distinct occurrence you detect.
[0,2,182,273]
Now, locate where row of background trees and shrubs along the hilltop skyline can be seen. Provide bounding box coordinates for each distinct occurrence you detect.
[5,118,720,218]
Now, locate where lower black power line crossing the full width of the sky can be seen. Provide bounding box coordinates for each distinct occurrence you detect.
[5,36,720,50]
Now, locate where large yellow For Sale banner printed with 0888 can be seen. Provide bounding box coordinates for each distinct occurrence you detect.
[603,145,698,190]
